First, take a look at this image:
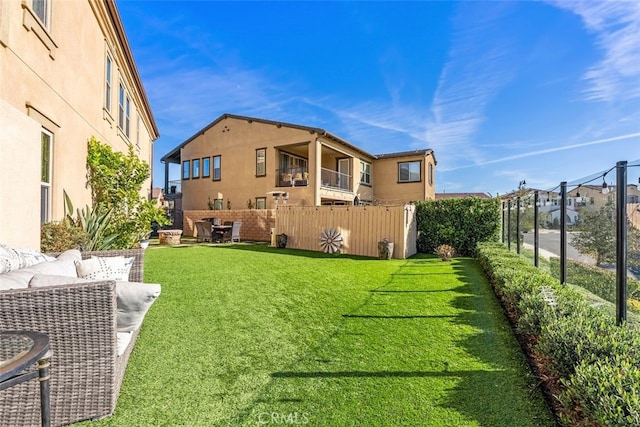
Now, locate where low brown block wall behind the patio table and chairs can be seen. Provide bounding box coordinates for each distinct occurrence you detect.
[182,209,276,242]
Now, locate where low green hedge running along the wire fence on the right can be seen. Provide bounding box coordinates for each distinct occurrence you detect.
[478,243,640,426]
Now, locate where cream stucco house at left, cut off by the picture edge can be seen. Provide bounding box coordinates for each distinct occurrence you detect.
[0,0,159,248]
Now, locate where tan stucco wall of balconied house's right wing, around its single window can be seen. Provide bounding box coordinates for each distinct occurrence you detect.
[372,152,435,204]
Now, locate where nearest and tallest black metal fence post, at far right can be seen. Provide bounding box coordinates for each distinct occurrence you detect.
[616,161,627,325]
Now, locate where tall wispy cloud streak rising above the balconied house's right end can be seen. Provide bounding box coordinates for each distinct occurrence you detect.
[426,2,512,171]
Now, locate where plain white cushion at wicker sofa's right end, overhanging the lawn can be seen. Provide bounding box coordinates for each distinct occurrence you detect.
[116,282,161,332]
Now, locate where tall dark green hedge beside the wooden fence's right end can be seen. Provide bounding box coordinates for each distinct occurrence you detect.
[416,197,501,256]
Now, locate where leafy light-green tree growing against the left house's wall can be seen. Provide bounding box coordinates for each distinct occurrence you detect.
[87,137,169,249]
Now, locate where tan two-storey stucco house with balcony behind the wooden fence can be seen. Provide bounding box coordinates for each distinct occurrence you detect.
[162,114,436,210]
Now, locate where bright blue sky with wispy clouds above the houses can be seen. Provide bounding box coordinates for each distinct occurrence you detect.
[117,0,640,195]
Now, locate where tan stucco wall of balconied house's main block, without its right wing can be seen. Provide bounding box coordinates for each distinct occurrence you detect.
[181,117,380,210]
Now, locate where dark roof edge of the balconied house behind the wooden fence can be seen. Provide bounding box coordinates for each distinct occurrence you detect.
[160,113,435,163]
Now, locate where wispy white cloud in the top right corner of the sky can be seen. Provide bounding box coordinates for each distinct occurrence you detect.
[549,0,640,101]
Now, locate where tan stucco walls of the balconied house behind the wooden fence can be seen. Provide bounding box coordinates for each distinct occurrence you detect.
[180,116,435,210]
